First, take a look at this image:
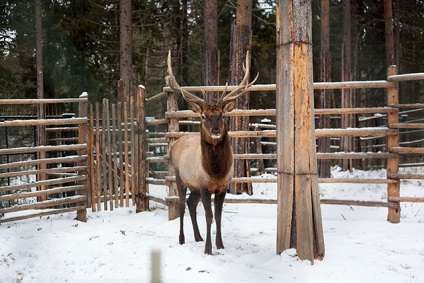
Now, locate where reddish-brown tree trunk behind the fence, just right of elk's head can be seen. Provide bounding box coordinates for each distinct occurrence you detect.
[230,0,253,195]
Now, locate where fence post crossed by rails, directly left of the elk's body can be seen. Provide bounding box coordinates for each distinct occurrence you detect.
[167,92,180,220]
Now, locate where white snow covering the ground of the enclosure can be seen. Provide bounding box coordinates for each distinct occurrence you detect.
[0,168,424,283]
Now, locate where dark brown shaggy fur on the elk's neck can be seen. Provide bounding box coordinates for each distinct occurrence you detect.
[200,126,233,178]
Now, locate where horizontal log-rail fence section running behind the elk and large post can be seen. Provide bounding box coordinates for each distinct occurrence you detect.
[146,66,424,222]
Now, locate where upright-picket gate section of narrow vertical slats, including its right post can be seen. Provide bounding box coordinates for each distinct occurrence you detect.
[89,87,148,211]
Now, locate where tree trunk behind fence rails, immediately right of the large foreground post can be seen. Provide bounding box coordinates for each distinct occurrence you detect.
[318,0,332,178]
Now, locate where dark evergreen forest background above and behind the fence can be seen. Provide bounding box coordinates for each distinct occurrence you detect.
[0,0,424,116]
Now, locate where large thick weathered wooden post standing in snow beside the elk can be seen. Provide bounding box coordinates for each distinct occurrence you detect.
[277,0,324,263]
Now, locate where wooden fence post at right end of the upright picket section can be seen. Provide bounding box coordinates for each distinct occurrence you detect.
[136,85,149,212]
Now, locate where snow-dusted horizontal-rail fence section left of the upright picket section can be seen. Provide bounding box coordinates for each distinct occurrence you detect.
[0,94,89,223]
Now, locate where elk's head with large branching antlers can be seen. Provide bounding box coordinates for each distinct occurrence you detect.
[166,51,259,144]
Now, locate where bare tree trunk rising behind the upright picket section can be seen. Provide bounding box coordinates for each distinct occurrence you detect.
[118,0,133,102]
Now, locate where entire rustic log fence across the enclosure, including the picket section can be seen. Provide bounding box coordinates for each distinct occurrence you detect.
[0,66,424,223]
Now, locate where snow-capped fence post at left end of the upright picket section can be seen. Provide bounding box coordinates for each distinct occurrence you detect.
[77,92,91,222]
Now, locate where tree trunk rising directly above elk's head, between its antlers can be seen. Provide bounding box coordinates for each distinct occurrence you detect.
[204,0,219,103]
